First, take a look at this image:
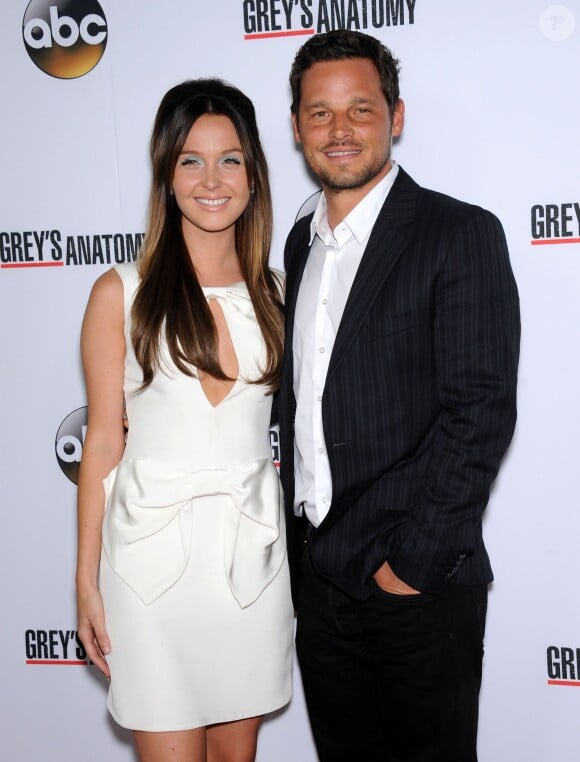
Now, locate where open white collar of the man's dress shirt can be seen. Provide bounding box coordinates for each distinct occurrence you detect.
[309,162,399,245]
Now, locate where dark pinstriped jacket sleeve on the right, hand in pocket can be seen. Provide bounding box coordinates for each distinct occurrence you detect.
[388,207,520,591]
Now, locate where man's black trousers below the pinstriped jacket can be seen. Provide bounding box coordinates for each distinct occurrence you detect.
[296,549,487,762]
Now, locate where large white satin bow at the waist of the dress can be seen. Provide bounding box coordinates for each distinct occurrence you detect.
[103,458,286,608]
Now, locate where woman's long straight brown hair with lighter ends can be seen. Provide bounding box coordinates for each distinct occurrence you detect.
[131,79,283,391]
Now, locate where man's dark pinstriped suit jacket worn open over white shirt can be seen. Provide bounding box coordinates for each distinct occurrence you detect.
[279,168,520,599]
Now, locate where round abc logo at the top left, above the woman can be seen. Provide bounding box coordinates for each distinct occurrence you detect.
[22,0,107,79]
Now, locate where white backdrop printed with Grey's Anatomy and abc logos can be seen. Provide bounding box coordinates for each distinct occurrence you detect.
[0,0,580,762]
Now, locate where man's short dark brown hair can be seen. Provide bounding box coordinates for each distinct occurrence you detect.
[290,29,400,117]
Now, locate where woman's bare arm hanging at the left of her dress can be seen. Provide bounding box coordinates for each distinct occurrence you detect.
[76,270,125,677]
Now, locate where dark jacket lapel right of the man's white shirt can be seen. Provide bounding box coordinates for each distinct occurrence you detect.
[327,167,419,379]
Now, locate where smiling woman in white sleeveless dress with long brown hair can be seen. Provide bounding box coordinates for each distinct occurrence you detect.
[77,80,292,762]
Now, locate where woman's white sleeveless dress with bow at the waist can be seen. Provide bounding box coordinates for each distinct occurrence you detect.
[100,264,293,731]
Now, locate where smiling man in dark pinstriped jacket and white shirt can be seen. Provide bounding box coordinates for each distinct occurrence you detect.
[279,31,519,762]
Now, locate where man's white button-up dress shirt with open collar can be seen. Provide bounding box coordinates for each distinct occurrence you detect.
[292,164,399,526]
